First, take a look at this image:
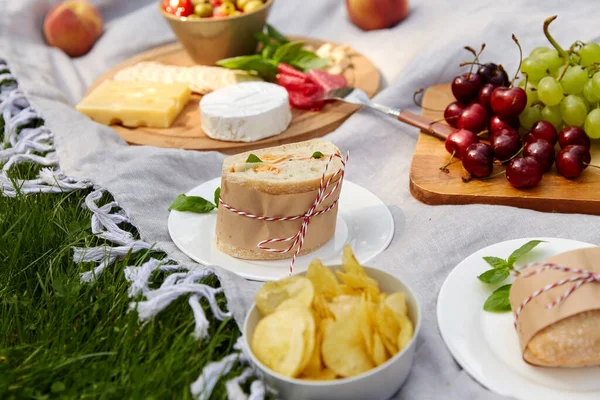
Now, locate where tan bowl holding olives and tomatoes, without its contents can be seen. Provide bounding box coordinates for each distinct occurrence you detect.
[158,0,275,65]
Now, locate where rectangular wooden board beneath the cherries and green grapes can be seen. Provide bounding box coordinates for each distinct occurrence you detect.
[410,85,600,215]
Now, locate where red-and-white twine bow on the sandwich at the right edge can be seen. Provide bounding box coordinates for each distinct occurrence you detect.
[514,262,600,328]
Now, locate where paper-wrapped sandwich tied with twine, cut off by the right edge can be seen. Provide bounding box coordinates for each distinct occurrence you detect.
[510,247,600,368]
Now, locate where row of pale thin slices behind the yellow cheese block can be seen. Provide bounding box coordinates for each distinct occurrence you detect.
[114,61,261,94]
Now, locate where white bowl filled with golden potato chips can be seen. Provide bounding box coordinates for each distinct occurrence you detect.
[243,247,421,400]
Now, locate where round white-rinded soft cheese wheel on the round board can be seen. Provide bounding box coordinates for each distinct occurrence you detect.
[200,82,292,142]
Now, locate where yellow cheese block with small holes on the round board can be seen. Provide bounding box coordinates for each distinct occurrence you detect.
[76,80,190,128]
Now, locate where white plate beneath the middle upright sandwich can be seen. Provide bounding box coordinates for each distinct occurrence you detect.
[169,178,394,281]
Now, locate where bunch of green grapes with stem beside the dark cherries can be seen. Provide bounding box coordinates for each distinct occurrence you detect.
[519,17,600,139]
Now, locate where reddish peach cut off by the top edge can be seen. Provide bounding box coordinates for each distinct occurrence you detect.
[346,0,408,31]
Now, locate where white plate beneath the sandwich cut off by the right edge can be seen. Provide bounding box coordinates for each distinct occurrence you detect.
[437,238,600,400]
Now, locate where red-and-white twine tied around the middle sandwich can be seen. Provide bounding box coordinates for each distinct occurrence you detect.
[219,153,350,275]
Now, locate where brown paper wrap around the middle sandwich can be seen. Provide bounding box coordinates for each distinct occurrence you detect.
[216,177,342,259]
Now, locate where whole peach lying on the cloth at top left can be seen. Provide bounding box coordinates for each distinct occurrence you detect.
[44,0,103,57]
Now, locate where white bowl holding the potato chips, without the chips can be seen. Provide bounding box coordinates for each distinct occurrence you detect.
[243,266,421,400]
